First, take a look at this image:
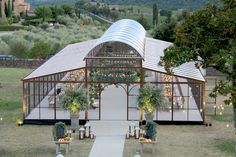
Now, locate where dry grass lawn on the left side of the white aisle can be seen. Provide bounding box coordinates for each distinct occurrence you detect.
[0,68,93,157]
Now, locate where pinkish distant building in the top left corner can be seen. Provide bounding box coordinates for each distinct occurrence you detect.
[0,0,30,18]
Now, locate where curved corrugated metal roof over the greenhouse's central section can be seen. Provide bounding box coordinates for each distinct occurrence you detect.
[88,19,146,57]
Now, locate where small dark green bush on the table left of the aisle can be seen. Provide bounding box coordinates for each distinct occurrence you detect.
[52,122,66,141]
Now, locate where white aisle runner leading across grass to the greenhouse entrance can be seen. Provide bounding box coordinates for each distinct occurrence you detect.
[89,121,138,157]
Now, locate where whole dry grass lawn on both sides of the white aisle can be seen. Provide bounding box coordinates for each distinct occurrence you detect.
[0,68,235,157]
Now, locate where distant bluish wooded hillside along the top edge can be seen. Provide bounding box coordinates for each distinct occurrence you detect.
[26,0,218,9]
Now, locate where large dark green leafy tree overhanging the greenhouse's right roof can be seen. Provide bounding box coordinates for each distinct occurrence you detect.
[159,0,236,127]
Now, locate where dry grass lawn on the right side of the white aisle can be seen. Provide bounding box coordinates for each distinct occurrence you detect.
[123,98,236,157]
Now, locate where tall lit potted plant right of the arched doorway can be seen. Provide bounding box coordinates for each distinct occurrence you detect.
[138,84,164,121]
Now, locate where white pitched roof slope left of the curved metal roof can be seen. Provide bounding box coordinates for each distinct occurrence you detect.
[24,40,96,80]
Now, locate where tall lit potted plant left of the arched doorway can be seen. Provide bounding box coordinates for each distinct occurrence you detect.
[60,89,88,131]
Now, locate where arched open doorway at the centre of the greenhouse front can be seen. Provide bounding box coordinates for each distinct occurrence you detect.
[101,85,127,120]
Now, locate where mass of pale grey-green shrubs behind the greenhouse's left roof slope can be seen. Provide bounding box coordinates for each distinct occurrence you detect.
[1,15,103,58]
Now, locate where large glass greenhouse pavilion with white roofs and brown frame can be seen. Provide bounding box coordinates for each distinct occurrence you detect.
[23,19,205,124]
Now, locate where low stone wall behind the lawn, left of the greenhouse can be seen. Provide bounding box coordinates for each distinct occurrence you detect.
[0,59,46,69]
